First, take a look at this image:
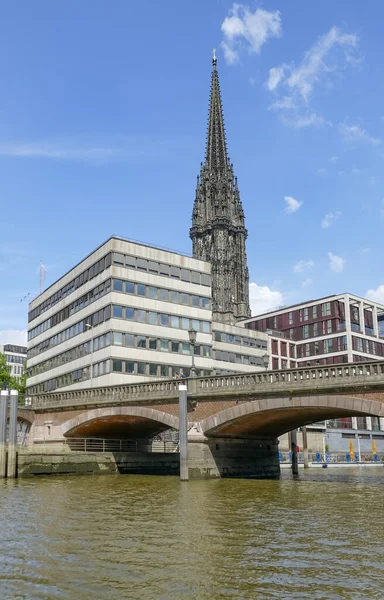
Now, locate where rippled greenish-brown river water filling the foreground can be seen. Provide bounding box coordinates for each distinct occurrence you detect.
[0,467,384,600]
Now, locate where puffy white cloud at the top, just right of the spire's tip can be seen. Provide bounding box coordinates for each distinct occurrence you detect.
[221,3,282,64]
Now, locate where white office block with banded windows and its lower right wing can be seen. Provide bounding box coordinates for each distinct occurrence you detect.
[27,237,268,395]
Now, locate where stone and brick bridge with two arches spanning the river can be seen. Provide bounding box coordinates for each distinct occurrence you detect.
[20,361,384,477]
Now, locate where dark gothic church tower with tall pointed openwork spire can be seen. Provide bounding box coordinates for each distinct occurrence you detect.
[190,53,251,324]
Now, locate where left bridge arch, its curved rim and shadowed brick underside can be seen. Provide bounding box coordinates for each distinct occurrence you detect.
[61,406,179,439]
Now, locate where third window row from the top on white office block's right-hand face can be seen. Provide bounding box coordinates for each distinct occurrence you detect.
[112,304,211,333]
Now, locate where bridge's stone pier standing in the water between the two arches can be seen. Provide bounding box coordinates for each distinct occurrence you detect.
[188,428,280,479]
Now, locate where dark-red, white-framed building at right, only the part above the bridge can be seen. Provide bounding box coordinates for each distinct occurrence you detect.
[244,294,384,369]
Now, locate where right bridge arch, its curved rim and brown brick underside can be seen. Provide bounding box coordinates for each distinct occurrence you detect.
[200,395,384,438]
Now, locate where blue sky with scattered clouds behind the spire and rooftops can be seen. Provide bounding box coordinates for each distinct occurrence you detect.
[0,0,384,343]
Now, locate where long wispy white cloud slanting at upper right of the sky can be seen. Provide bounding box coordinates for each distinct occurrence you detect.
[266,26,358,128]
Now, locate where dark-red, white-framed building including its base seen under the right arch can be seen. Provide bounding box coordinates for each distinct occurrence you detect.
[244,293,384,451]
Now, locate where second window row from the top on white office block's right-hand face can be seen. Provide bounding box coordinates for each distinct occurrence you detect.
[113,279,211,309]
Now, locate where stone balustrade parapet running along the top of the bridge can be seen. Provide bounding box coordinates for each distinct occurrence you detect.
[29,361,384,411]
